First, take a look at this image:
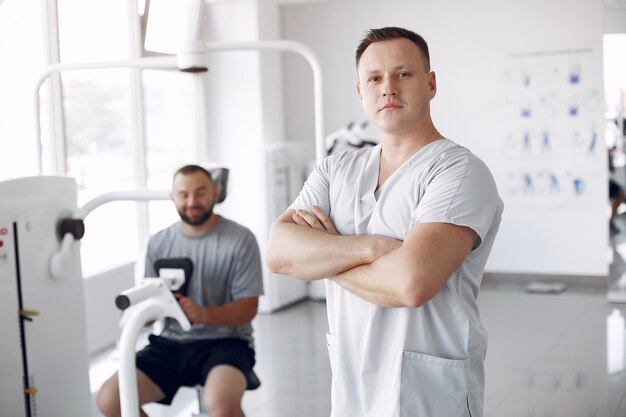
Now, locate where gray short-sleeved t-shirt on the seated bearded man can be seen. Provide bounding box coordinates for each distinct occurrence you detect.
[145,217,263,347]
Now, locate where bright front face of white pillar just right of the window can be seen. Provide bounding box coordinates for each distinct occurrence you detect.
[205,0,264,234]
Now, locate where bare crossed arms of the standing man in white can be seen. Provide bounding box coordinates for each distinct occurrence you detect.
[266,207,478,307]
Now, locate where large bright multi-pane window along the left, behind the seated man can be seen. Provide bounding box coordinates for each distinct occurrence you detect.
[0,0,197,277]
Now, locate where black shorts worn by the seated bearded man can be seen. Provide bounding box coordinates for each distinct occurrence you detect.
[136,335,255,405]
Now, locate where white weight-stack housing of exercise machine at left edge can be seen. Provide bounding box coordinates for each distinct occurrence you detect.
[0,176,91,417]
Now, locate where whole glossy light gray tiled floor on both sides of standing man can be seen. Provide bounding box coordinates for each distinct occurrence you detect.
[91,222,626,417]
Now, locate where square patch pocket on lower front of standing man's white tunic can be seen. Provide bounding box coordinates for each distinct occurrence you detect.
[400,351,470,417]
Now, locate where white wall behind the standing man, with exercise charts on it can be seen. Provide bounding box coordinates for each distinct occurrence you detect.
[282,0,608,275]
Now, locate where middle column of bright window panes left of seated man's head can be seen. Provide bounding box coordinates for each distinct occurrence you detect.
[58,0,138,277]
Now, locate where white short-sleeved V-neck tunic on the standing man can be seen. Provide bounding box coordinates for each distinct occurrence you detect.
[291,139,503,417]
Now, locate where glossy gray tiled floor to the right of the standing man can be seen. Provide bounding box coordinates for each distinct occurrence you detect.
[480,287,604,417]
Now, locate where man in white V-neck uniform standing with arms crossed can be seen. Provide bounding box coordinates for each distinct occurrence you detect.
[266,27,503,417]
